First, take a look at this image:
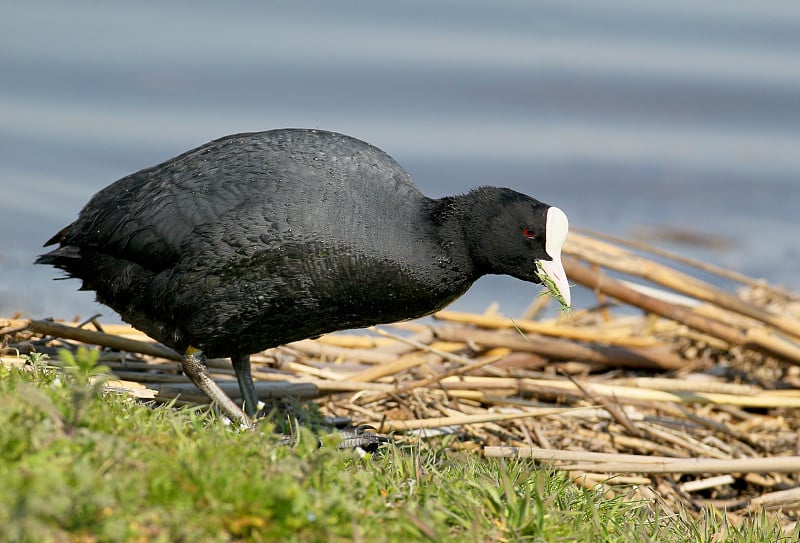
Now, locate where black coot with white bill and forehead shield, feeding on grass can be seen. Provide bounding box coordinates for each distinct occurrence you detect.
[36,129,569,424]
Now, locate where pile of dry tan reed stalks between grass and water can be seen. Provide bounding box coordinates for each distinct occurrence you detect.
[0,233,800,525]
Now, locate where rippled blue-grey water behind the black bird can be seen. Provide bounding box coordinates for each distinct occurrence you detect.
[0,0,800,317]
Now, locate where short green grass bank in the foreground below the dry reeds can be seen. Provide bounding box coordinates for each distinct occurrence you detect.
[0,350,797,543]
